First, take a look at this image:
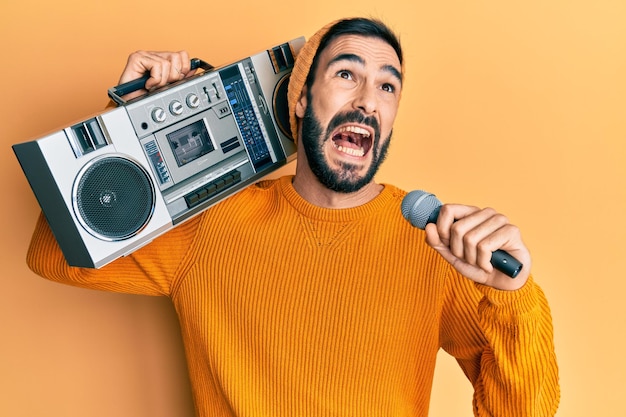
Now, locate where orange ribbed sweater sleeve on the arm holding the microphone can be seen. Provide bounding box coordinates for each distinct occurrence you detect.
[441,275,560,417]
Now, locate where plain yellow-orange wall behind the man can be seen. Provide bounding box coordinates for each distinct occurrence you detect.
[0,0,626,417]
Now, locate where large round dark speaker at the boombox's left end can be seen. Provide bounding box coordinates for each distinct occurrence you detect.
[73,155,155,241]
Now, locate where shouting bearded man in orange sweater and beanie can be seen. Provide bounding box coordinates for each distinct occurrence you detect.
[28,19,559,417]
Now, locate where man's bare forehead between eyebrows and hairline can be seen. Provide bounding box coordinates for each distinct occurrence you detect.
[320,35,401,71]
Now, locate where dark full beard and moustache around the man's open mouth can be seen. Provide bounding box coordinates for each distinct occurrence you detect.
[300,100,391,193]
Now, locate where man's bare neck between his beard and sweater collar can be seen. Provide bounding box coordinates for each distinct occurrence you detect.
[293,169,383,209]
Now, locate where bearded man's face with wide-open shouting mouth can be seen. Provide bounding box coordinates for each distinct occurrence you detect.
[296,35,402,192]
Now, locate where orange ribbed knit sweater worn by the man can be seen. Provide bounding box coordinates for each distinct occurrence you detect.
[28,177,559,417]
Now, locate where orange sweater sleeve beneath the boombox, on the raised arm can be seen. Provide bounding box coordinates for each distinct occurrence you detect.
[26,214,197,295]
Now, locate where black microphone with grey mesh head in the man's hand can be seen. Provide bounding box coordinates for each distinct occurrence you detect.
[401,190,523,278]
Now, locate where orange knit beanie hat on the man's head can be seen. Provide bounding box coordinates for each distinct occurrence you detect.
[287,20,338,141]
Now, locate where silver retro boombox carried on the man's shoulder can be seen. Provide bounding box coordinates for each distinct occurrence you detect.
[13,37,304,268]
